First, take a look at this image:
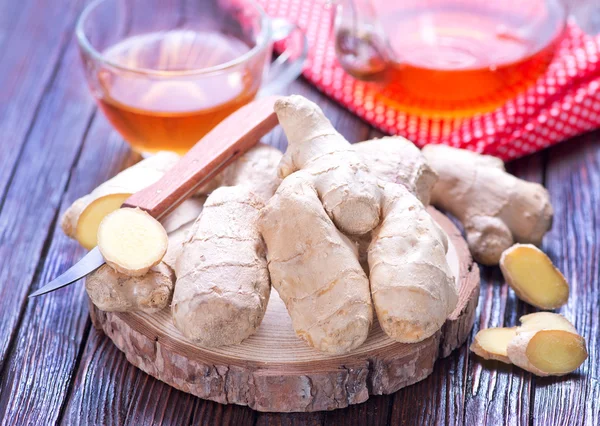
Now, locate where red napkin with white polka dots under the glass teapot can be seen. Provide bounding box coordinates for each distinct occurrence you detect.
[259,0,600,160]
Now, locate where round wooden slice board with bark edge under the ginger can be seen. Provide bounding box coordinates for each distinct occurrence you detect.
[90,209,479,412]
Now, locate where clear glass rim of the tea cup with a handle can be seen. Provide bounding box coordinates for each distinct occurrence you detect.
[75,0,271,77]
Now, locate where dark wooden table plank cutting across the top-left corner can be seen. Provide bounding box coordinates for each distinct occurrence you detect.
[0,0,83,211]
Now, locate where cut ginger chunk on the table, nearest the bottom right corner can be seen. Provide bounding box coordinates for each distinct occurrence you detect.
[471,312,588,376]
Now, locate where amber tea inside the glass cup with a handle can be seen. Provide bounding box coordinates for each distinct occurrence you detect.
[98,30,260,153]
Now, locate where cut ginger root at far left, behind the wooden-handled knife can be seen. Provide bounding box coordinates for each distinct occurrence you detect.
[61,152,179,250]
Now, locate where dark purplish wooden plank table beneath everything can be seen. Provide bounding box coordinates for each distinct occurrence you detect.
[0,0,600,426]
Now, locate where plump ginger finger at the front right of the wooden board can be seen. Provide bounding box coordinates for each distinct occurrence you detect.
[368,183,458,343]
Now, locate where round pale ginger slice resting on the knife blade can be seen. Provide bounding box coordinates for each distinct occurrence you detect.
[98,208,169,277]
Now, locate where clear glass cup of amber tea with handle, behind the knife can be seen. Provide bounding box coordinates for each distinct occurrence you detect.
[76,0,307,154]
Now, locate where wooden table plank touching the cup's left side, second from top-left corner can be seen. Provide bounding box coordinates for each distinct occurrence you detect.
[0,29,93,382]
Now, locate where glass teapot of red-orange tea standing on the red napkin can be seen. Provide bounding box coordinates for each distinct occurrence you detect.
[334,0,567,117]
